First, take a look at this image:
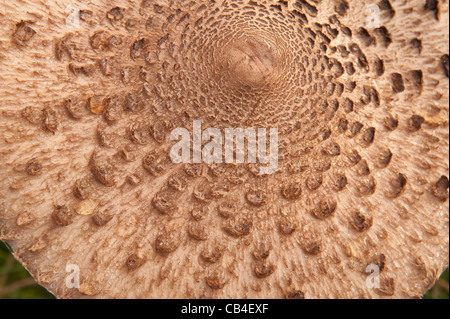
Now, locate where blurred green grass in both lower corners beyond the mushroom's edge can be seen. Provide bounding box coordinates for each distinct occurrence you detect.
[0,241,449,299]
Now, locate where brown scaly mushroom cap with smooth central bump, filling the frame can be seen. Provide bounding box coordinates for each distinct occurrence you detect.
[0,0,449,298]
